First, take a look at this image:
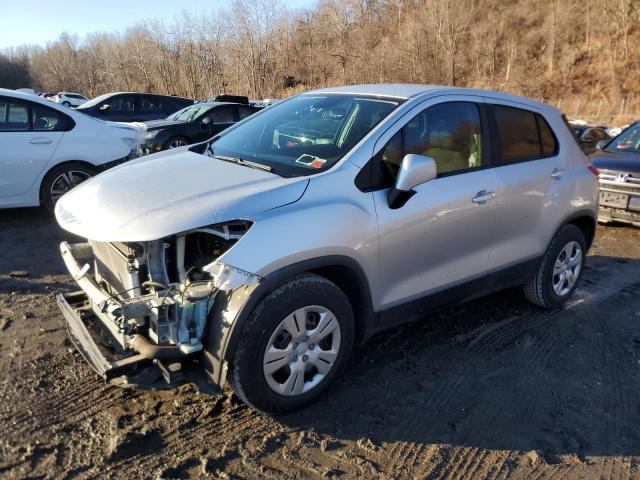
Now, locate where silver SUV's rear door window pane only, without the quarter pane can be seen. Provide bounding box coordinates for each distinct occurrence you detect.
[493,105,542,163]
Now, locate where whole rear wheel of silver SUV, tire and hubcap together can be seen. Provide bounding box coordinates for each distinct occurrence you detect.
[524,225,587,308]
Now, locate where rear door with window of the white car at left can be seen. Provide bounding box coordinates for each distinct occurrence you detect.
[0,96,65,197]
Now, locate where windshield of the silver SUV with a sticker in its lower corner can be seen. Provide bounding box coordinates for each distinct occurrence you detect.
[208,94,401,177]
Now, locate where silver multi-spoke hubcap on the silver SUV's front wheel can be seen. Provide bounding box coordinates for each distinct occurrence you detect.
[262,305,340,396]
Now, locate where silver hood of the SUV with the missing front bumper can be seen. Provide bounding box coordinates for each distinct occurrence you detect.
[55,148,309,242]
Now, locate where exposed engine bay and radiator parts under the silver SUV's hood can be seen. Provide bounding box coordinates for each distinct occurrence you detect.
[61,221,259,358]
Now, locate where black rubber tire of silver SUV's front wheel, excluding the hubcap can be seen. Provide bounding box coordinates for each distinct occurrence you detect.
[229,274,354,414]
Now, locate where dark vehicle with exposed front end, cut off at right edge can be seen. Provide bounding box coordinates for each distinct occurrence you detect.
[591,122,640,226]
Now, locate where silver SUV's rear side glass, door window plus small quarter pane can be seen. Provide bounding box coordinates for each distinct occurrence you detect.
[492,105,558,165]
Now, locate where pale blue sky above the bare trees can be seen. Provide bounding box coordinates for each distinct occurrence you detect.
[0,0,316,49]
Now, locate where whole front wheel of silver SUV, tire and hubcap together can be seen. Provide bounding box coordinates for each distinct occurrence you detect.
[230,274,354,414]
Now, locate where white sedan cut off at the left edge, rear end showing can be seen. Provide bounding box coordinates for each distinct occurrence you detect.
[0,89,142,209]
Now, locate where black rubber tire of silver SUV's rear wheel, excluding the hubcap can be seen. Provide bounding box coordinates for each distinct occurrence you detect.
[524,225,587,308]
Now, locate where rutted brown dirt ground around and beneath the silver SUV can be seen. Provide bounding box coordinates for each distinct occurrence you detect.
[0,209,640,479]
